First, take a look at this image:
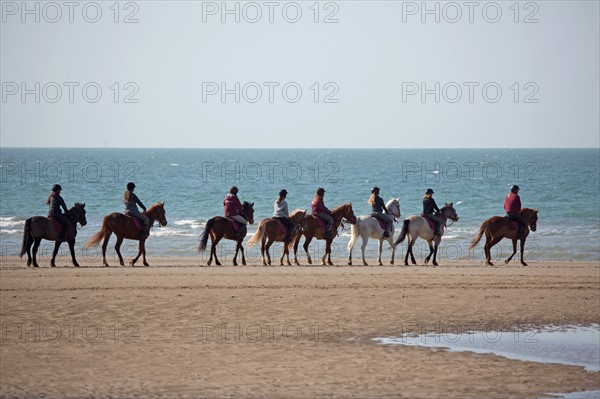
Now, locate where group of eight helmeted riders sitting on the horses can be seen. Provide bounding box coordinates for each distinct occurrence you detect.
[46,182,527,242]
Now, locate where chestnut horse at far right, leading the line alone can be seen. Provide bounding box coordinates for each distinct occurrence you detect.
[469,208,538,266]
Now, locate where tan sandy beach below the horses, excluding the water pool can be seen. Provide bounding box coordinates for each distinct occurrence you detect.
[0,257,600,398]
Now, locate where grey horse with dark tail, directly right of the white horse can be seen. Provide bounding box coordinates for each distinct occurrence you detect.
[394,203,458,266]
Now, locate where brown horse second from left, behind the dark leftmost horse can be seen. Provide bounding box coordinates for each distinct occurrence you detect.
[84,202,167,266]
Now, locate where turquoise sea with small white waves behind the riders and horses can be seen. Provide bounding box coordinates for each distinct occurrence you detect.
[0,148,600,264]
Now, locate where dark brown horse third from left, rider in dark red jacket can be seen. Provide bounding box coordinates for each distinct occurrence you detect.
[198,201,254,266]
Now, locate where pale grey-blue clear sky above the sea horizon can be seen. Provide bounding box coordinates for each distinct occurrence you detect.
[0,1,600,148]
